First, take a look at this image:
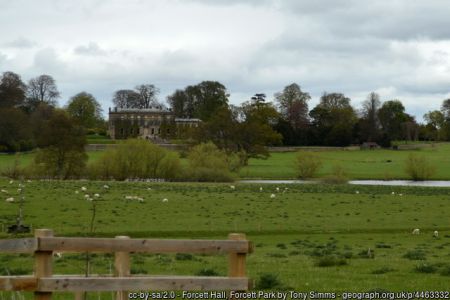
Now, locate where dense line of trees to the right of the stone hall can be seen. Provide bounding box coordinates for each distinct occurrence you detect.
[163,81,450,154]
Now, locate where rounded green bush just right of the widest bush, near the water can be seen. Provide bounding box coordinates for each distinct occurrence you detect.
[186,142,238,182]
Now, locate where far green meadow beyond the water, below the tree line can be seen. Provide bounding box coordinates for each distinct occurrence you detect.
[0,143,450,180]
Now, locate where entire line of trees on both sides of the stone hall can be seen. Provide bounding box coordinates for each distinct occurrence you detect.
[0,72,450,156]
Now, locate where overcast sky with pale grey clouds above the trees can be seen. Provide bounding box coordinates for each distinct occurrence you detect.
[0,0,450,120]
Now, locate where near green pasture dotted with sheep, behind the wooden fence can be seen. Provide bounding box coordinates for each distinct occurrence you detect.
[0,179,450,299]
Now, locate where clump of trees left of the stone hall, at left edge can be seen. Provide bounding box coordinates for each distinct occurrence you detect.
[0,72,106,152]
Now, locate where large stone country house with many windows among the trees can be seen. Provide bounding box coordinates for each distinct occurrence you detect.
[108,106,201,140]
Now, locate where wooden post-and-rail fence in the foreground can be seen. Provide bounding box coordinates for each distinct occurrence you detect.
[0,229,253,300]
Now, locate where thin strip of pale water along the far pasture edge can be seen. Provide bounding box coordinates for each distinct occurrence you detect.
[243,179,450,187]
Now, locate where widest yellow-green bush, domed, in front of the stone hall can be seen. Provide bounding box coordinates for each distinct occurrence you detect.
[89,139,181,180]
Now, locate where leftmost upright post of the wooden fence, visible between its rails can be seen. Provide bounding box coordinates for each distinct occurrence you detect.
[34,229,53,300]
